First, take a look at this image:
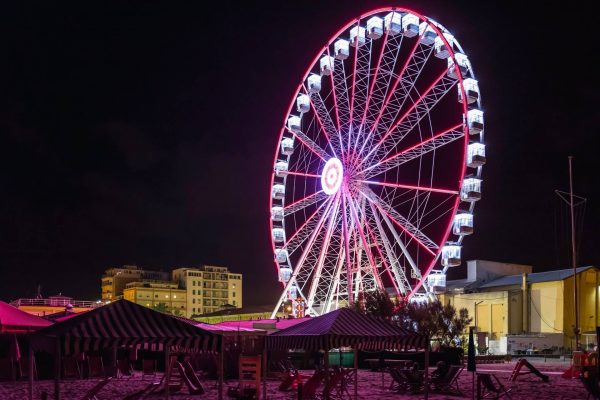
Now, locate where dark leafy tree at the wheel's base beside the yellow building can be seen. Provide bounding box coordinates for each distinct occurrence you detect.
[396,300,473,346]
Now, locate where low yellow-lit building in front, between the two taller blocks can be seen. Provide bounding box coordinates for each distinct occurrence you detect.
[123,281,187,316]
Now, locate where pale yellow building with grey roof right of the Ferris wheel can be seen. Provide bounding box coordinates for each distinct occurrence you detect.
[440,260,600,351]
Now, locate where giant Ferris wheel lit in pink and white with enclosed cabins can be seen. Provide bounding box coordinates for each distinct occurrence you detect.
[269,8,486,315]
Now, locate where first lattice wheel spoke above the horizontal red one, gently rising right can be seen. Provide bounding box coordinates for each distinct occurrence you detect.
[363,123,465,179]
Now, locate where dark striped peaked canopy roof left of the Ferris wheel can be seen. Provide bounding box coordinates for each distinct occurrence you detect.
[34,300,221,354]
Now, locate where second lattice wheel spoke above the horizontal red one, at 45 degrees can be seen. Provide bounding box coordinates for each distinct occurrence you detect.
[371,74,462,166]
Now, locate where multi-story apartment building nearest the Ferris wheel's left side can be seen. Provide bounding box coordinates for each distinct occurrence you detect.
[173,265,243,317]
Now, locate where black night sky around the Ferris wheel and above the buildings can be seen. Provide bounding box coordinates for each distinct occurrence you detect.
[0,1,600,304]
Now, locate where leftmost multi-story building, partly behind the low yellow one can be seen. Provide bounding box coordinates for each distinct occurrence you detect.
[102,265,170,302]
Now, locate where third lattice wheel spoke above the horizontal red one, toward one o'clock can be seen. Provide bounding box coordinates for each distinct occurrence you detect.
[360,32,433,154]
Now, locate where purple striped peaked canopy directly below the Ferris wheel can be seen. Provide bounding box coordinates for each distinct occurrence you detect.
[266,308,427,351]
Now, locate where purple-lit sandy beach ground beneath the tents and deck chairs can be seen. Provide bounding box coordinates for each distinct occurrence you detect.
[0,360,587,400]
